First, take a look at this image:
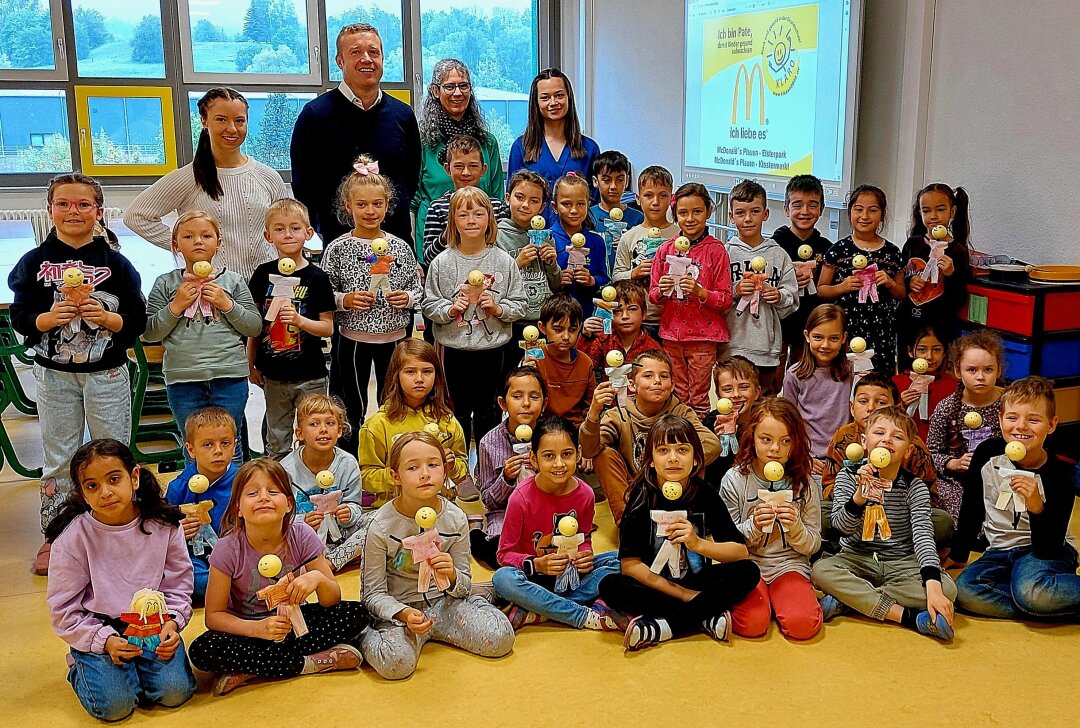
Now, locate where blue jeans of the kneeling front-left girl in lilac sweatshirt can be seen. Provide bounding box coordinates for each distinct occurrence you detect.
[68,643,198,720]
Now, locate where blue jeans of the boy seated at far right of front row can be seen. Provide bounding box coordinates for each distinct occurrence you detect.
[956,544,1080,619]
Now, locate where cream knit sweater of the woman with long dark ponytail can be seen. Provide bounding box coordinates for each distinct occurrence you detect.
[124,157,288,281]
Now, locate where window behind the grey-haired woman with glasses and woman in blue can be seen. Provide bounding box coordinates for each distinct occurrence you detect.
[420,0,539,161]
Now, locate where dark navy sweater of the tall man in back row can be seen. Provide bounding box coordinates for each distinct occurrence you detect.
[289,89,420,244]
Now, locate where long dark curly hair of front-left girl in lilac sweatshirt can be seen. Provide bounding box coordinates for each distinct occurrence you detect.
[45,439,183,543]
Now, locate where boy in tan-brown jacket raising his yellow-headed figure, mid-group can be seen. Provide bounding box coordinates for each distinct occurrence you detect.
[581,349,720,524]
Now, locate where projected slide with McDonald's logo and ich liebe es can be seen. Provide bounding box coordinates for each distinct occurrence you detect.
[685,0,850,181]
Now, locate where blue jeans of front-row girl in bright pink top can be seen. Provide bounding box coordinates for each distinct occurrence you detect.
[491,551,619,630]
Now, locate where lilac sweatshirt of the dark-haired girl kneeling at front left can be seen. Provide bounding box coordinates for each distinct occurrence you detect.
[48,513,194,653]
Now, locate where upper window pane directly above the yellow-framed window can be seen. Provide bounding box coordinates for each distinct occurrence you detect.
[71,0,165,79]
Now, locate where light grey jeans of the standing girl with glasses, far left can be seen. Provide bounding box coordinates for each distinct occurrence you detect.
[33,364,132,530]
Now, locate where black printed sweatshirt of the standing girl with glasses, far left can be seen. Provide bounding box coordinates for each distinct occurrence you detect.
[8,231,146,373]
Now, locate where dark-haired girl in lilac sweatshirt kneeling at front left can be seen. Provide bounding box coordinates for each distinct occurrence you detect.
[45,440,197,720]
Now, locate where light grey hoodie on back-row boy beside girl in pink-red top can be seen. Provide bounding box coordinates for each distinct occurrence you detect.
[726,238,799,366]
